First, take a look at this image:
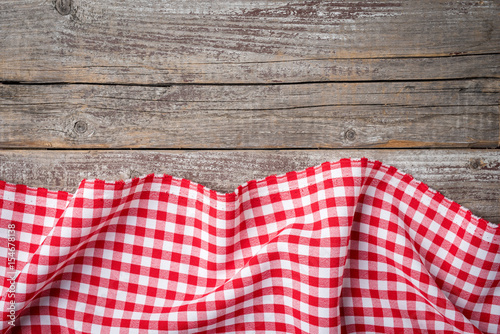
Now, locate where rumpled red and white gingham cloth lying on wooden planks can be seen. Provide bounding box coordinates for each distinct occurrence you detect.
[0,159,500,333]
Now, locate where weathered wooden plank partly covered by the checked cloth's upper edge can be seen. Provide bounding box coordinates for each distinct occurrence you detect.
[0,149,500,223]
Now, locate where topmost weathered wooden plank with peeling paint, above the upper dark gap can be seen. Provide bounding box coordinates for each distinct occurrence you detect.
[0,0,500,84]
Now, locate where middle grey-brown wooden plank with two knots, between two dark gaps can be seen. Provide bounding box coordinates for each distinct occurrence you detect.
[0,79,500,149]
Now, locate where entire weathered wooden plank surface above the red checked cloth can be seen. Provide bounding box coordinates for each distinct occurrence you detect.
[0,0,500,223]
